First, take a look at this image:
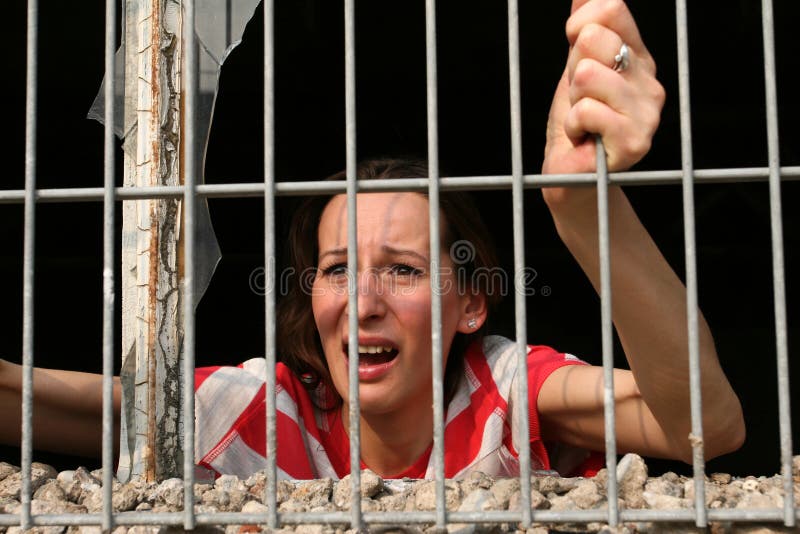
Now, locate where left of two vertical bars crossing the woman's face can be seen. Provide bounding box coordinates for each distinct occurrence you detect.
[344,0,360,530]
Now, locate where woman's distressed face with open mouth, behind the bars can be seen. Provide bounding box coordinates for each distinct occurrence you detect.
[311,193,485,414]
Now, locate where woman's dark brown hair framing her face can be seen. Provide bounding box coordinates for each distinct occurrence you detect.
[277,159,500,407]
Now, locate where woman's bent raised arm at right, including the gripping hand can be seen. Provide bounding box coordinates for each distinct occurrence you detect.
[538,0,745,461]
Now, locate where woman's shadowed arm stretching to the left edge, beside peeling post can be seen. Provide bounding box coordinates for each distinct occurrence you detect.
[0,360,120,457]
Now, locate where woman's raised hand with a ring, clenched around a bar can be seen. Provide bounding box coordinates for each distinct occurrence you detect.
[542,0,664,197]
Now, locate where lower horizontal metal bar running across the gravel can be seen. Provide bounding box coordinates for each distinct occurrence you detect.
[0,508,800,526]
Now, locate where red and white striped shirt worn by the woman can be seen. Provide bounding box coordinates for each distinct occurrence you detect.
[195,336,597,479]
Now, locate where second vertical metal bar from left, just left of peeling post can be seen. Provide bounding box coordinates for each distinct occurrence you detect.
[102,0,118,532]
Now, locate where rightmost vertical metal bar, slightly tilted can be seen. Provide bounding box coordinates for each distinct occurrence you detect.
[761,0,795,527]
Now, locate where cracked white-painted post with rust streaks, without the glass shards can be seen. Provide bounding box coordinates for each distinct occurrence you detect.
[118,0,184,486]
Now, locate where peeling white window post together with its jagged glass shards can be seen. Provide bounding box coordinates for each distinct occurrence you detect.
[88,0,259,481]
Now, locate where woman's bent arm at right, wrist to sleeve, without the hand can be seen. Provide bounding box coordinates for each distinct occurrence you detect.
[539,188,745,461]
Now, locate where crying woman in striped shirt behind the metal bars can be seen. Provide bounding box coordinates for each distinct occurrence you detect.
[0,0,744,484]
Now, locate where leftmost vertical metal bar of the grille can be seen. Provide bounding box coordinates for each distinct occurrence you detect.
[20,0,39,530]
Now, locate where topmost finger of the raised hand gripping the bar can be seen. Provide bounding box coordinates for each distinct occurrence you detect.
[566,0,649,57]
